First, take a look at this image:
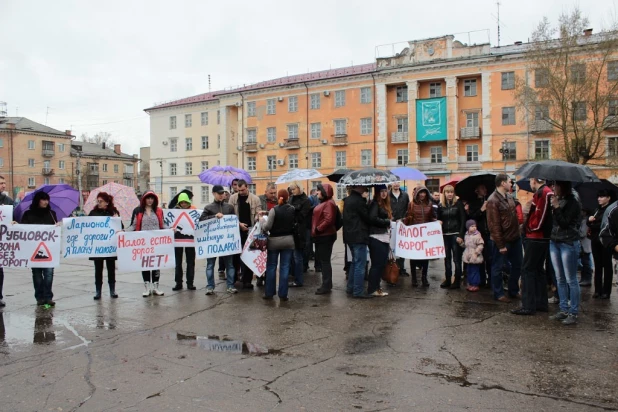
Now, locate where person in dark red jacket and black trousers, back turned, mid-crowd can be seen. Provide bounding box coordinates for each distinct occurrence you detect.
[311,183,339,295]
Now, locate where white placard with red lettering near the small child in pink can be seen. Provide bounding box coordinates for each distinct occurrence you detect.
[395,222,445,260]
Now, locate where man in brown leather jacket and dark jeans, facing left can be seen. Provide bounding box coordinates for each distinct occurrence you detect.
[487,174,522,303]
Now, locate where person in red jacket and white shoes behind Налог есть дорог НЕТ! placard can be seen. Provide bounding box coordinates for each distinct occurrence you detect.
[126,190,167,298]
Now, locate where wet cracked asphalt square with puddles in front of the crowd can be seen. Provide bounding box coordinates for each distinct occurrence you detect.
[0,241,618,411]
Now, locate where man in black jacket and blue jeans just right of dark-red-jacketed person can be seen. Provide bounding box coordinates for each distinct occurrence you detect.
[343,186,372,299]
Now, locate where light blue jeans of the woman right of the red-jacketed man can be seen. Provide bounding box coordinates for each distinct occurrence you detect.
[549,240,580,315]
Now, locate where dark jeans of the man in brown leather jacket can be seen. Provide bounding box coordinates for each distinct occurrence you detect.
[489,238,523,299]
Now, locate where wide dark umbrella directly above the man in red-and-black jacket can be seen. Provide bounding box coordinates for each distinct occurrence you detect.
[515,160,599,183]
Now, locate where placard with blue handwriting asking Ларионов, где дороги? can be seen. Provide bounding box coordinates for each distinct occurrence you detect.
[62,216,122,259]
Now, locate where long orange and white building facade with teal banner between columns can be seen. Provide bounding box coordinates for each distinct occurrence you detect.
[146,32,618,204]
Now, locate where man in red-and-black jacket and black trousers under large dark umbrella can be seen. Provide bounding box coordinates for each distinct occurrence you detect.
[511,179,554,315]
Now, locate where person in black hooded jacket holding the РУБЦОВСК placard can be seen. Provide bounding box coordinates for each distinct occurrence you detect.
[20,191,58,306]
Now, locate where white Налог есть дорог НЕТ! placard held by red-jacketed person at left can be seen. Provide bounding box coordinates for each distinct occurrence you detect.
[117,229,176,272]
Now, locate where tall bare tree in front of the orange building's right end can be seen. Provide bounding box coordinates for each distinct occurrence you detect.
[515,9,618,164]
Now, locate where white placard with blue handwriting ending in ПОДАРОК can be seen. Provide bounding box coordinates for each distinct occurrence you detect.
[195,215,242,259]
